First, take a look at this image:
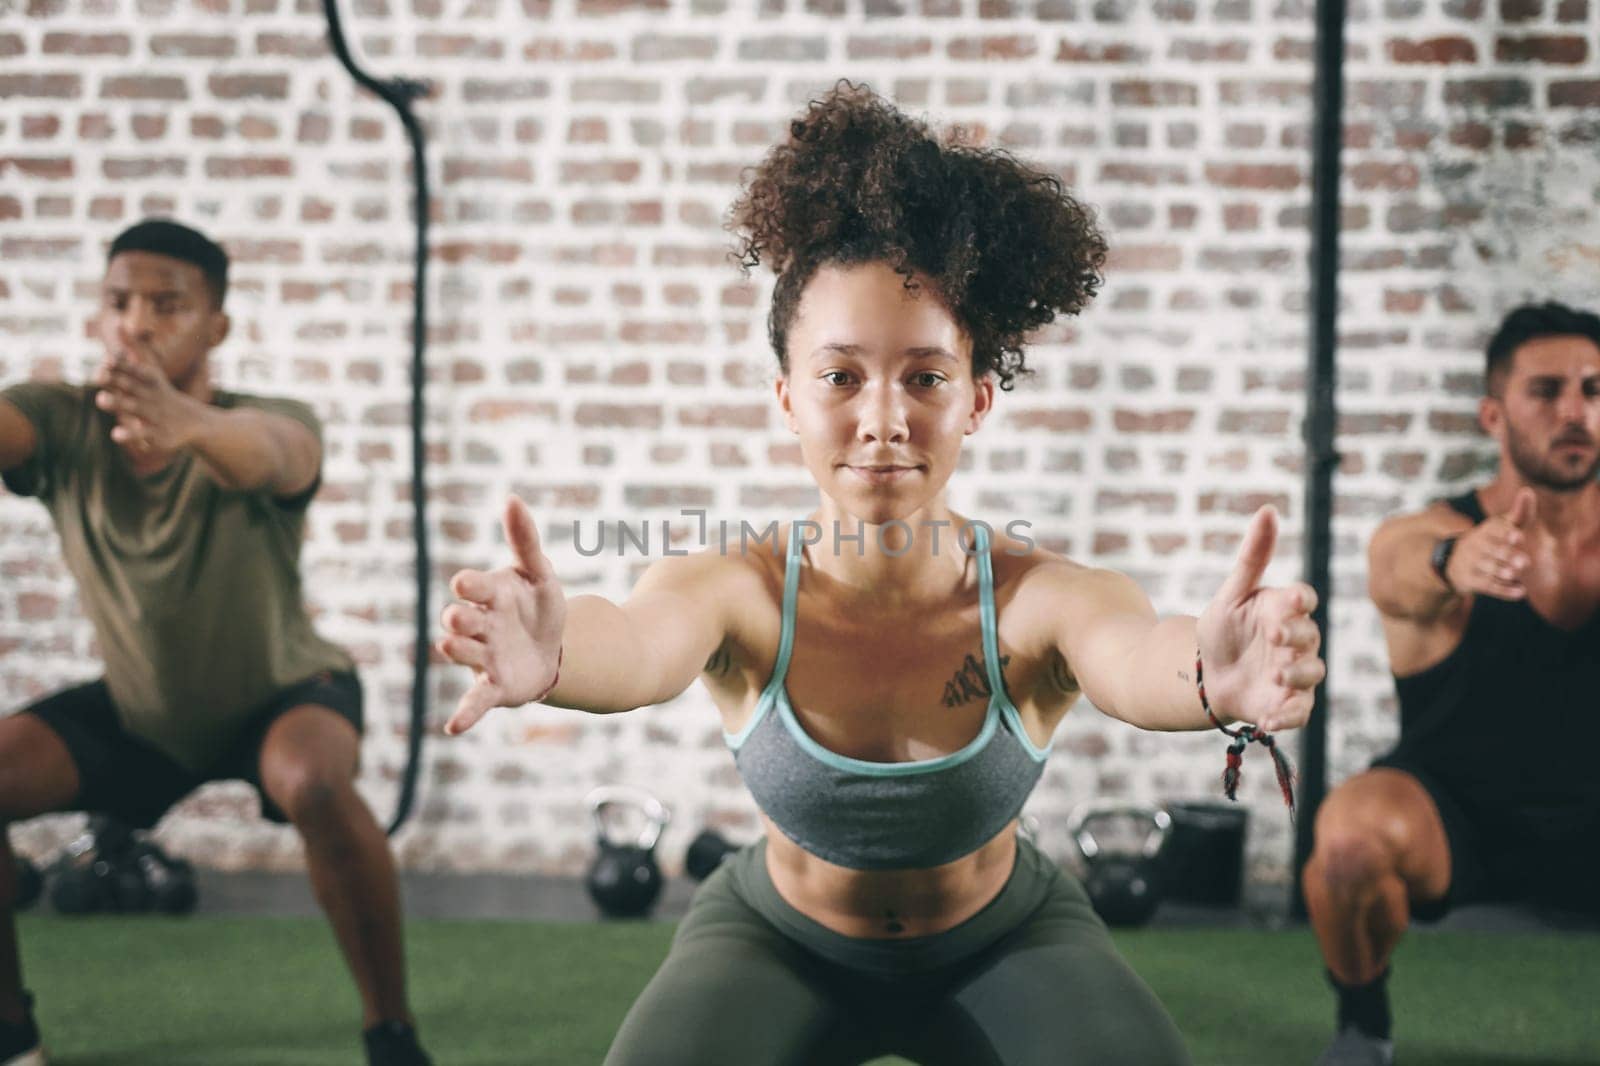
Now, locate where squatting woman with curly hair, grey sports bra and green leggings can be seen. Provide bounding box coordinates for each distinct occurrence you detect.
[440,83,1323,1066]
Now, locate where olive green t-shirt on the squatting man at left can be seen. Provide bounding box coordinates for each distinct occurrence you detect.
[0,383,354,773]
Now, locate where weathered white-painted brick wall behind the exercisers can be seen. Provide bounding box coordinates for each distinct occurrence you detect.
[0,0,1600,880]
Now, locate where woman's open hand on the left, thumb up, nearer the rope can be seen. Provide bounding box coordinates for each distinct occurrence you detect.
[434,496,566,735]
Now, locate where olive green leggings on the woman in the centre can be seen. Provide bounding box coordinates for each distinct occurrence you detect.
[605,840,1189,1066]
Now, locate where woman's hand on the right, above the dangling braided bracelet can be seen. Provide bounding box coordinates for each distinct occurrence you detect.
[1195,507,1328,733]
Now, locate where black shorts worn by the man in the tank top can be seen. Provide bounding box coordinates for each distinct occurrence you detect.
[1373,752,1600,922]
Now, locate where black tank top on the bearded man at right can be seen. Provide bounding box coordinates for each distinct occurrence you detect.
[1390,491,1600,840]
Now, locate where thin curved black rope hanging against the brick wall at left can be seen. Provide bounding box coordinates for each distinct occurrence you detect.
[322,0,432,834]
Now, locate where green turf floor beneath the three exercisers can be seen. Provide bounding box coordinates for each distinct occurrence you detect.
[19,914,1600,1066]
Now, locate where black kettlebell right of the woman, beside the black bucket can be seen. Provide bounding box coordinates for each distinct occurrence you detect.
[1067,804,1173,927]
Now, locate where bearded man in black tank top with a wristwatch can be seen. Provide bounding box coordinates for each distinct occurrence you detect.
[1304,303,1600,1066]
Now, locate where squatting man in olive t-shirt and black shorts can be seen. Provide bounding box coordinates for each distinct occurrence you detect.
[0,221,429,1066]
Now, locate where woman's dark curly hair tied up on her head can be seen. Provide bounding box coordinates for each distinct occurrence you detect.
[731,82,1106,389]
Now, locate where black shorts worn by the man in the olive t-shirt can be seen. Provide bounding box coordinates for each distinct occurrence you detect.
[22,671,362,829]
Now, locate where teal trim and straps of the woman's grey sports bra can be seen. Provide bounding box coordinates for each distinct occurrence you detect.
[723,523,1054,765]
